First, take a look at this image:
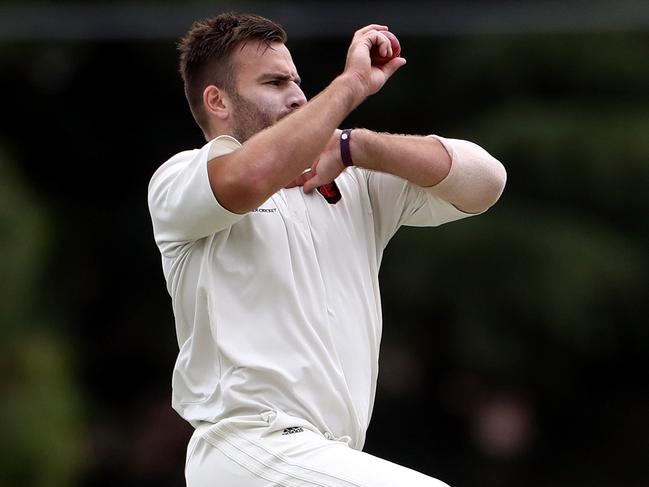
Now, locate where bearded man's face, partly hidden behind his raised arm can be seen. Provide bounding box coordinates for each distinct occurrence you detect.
[225,41,306,143]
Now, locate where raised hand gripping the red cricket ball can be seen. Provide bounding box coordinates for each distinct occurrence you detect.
[343,24,406,96]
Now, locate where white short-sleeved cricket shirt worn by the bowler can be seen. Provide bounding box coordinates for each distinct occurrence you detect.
[149,136,469,449]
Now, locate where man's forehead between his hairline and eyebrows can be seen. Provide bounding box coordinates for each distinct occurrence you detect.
[233,41,297,80]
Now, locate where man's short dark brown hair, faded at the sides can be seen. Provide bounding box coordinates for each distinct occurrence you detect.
[178,12,287,134]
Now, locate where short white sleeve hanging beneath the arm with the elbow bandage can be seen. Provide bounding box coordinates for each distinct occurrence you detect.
[362,170,471,246]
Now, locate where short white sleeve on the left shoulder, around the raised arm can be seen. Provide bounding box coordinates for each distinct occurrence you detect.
[148,136,243,254]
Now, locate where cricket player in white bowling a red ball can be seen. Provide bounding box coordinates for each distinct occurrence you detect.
[148,13,506,487]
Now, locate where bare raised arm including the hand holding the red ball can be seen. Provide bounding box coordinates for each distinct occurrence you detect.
[208,25,406,213]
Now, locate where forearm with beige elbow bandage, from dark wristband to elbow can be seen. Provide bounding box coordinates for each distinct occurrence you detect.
[350,130,506,213]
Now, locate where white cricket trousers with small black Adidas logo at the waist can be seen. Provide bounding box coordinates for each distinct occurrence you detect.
[185,411,448,487]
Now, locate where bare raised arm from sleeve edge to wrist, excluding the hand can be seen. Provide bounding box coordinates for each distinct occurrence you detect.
[208,75,363,213]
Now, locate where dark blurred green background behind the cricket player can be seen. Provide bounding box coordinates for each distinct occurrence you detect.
[0,1,649,487]
